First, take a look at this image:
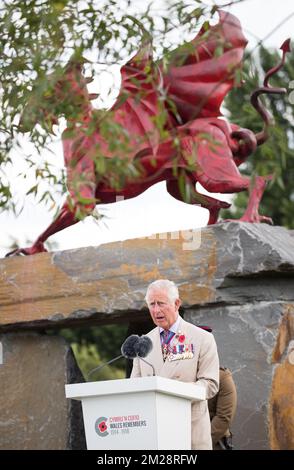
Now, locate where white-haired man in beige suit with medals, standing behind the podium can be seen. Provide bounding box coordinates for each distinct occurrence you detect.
[131,279,219,450]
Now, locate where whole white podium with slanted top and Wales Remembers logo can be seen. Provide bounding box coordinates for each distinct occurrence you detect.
[65,376,206,450]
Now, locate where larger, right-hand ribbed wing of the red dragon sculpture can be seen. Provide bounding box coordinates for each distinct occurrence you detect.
[159,11,247,124]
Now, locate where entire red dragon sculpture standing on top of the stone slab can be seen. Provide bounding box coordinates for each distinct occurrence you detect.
[7,11,289,256]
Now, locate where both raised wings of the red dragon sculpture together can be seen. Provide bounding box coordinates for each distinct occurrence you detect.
[110,11,247,156]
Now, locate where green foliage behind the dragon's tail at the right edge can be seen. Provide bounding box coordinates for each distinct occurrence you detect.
[221,47,294,229]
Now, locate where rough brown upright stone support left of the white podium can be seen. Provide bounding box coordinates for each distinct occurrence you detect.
[0,333,85,450]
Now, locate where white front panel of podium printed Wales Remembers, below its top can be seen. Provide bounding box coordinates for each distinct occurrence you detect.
[82,392,191,450]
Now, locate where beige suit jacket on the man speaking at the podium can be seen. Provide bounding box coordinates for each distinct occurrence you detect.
[131,319,219,450]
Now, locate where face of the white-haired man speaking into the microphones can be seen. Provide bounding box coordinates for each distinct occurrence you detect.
[148,289,181,330]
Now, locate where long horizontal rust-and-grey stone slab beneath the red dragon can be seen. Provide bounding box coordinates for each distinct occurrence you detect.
[0,223,294,331]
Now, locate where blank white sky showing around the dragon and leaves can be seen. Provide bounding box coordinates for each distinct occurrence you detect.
[0,0,294,257]
